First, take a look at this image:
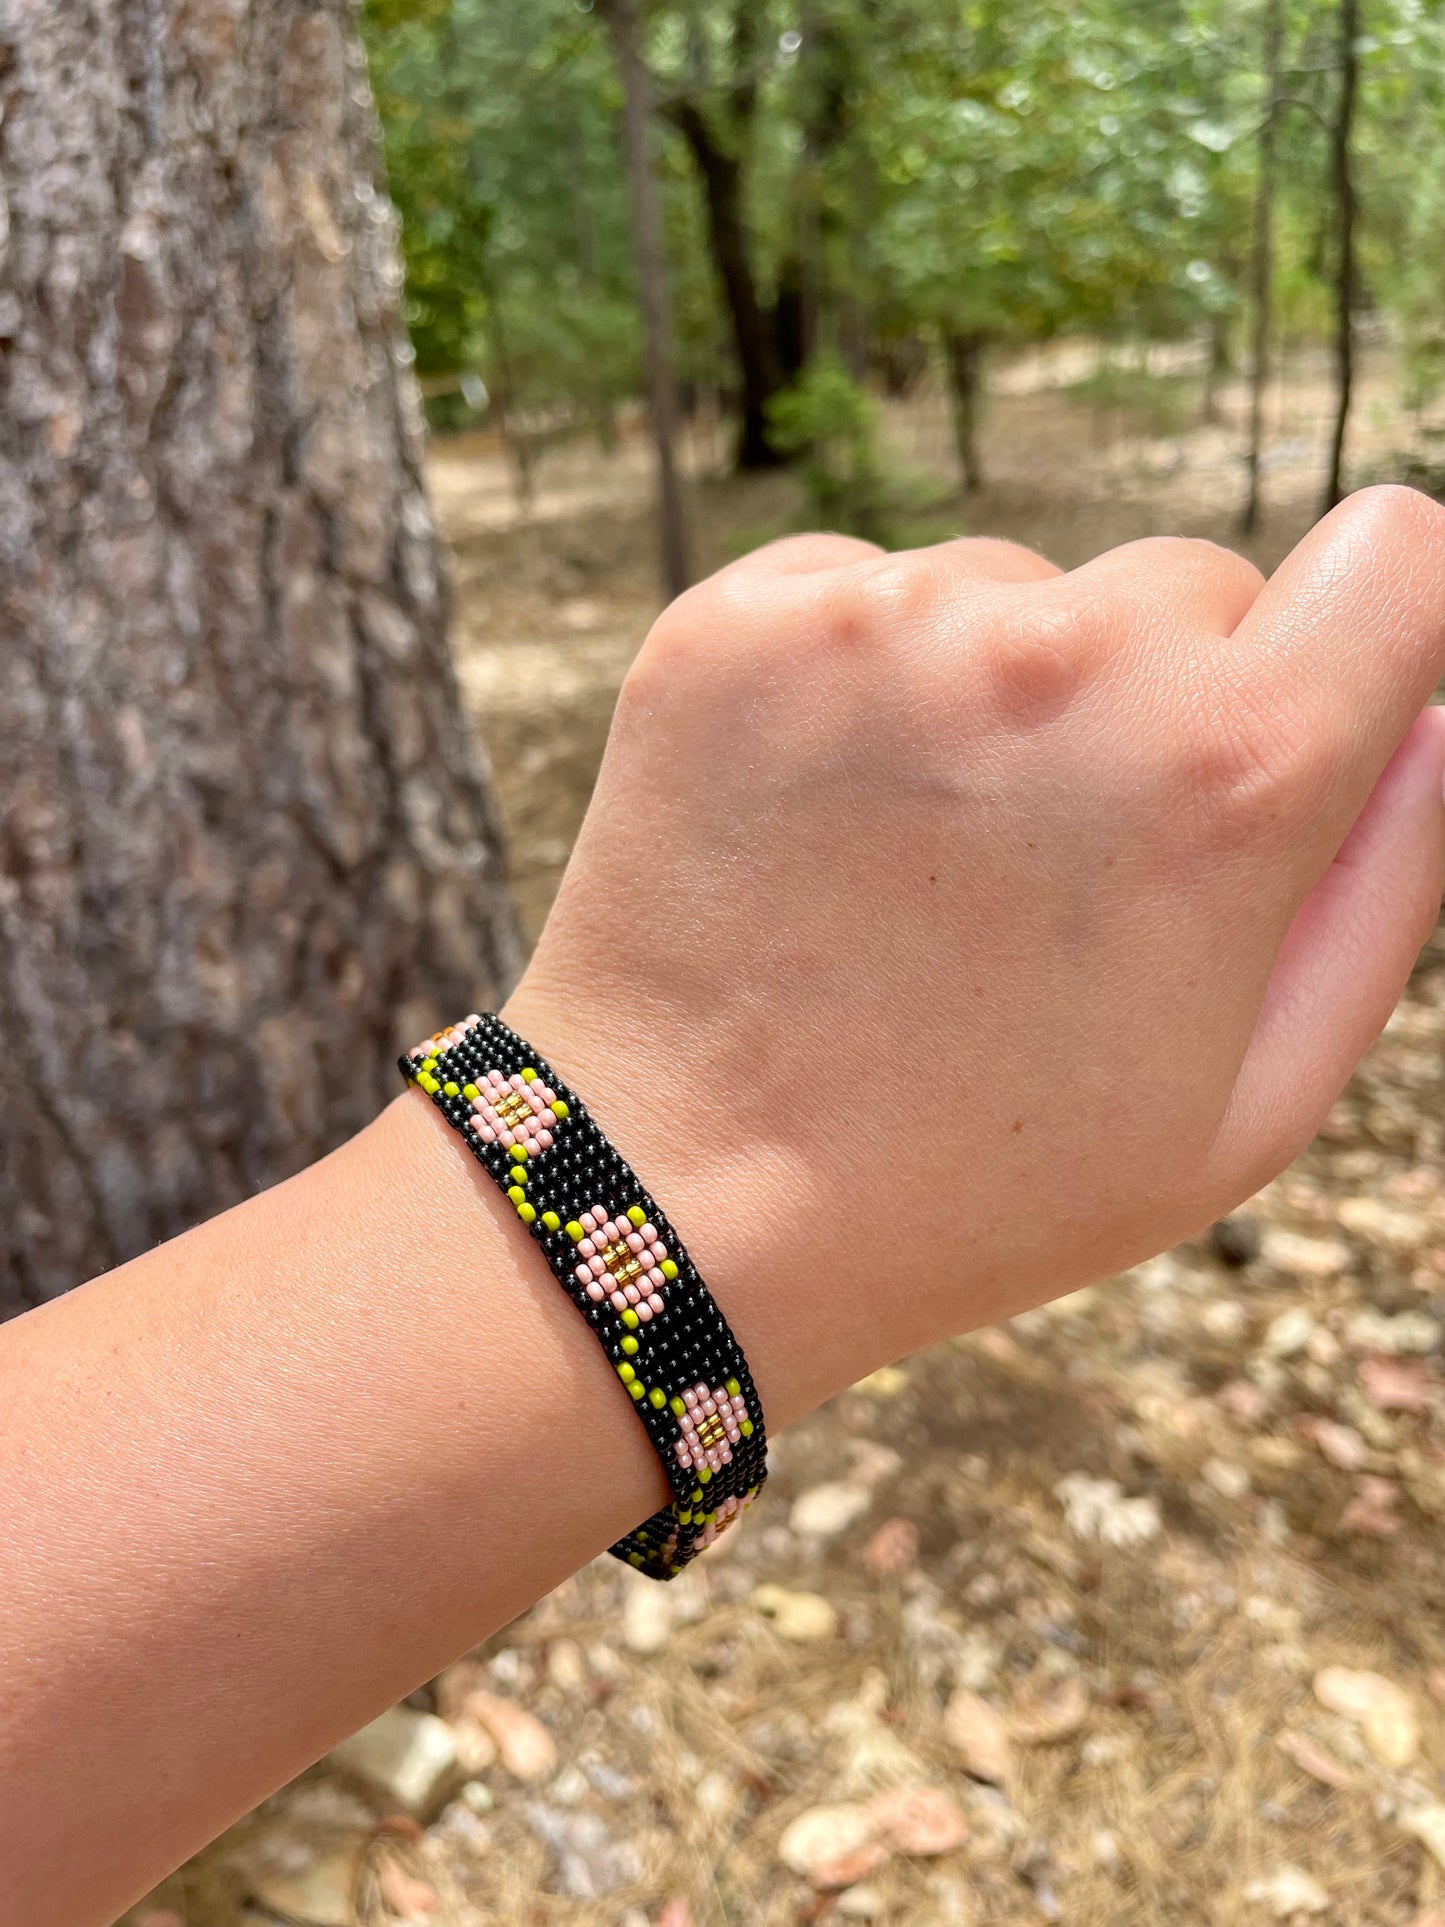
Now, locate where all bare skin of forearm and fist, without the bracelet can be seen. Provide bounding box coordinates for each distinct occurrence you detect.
[0,489,1445,1927]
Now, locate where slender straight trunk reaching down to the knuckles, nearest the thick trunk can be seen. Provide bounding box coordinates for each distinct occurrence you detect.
[601,0,692,595]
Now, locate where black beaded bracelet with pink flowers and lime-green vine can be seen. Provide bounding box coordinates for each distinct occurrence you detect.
[399,1012,767,1578]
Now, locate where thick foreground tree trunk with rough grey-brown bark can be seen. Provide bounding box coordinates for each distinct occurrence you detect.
[0,0,520,1314]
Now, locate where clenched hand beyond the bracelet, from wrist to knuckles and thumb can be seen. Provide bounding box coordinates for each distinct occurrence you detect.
[507,489,1445,1424]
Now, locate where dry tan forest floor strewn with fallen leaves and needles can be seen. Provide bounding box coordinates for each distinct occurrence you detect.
[127,360,1445,1927]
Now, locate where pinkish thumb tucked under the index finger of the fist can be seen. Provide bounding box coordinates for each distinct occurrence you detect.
[1216,709,1445,1183]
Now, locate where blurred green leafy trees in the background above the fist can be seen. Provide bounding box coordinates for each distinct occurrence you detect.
[366,0,1445,558]
